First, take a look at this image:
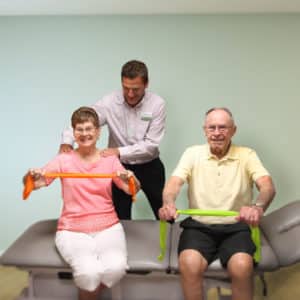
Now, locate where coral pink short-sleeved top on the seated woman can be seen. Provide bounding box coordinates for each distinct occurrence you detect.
[43,151,124,232]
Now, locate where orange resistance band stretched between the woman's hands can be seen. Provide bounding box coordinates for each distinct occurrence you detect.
[23,173,136,202]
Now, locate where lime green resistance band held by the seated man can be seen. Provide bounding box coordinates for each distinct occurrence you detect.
[158,209,261,263]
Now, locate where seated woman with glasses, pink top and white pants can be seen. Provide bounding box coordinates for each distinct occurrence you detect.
[24,107,140,300]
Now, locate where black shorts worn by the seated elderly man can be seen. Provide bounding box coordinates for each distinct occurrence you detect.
[178,217,256,267]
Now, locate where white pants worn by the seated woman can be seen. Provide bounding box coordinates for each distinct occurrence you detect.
[55,223,127,292]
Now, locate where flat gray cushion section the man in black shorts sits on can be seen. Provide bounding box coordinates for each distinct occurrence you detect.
[170,222,279,276]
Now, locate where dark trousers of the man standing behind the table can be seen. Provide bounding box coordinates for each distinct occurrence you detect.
[112,158,165,220]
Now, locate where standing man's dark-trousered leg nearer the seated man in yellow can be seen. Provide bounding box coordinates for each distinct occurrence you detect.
[136,158,165,220]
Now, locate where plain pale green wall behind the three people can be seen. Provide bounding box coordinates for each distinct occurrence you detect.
[0,14,300,250]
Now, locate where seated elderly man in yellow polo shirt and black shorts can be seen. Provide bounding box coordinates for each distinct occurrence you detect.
[159,108,275,300]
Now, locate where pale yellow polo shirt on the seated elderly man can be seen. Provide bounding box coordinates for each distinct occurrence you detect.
[172,144,269,224]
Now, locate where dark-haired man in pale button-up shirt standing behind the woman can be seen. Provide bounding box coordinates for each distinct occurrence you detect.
[60,60,166,219]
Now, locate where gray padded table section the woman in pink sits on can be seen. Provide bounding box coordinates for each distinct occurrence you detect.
[0,220,170,271]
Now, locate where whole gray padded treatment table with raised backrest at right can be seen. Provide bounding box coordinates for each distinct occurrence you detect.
[0,201,300,300]
